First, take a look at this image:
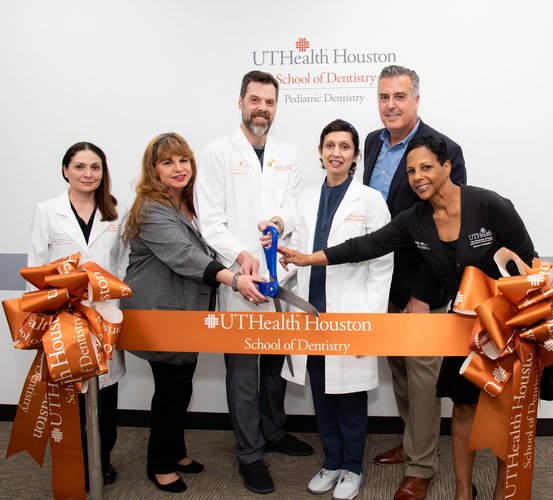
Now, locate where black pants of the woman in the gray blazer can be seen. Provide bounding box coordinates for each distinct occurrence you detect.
[147,361,197,474]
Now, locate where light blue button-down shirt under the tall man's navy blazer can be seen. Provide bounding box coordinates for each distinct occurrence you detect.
[369,118,421,200]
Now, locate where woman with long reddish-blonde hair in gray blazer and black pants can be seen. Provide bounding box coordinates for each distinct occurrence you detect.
[122,133,266,493]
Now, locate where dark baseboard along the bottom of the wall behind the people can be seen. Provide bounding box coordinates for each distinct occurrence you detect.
[0,405,553,436]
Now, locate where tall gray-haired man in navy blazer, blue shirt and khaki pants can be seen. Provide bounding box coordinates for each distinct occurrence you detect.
[363,66,466,500]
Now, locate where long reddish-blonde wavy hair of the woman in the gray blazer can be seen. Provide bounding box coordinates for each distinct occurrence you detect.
[123,132,196,241]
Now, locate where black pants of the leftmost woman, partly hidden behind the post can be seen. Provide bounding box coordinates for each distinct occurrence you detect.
[79,383,119,477]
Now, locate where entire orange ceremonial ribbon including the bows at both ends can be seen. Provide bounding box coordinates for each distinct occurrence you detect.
[4,249,553,499]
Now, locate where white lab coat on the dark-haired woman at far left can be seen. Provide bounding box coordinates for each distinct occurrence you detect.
[27,191,129,389]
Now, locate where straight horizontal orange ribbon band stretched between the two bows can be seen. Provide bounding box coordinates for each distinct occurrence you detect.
[117,310,474,356]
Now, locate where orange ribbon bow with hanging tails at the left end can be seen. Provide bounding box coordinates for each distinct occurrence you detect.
[3,253,131,500]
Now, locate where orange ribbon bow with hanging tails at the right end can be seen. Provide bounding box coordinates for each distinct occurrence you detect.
[454,248,553,499]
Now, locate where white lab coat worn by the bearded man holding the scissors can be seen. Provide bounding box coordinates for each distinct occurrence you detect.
[194,127,300,312]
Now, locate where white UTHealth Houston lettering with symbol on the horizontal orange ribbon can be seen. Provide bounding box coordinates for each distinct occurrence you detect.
[204,312,372,332]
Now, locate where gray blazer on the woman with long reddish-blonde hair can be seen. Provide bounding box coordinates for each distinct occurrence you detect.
[121,202,224,365]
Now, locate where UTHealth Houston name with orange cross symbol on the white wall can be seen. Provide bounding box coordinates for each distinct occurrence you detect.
[252,36,397,66]
